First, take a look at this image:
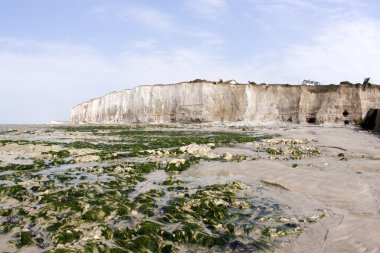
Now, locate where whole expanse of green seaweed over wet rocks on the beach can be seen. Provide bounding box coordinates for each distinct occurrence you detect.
[0,125,313,253]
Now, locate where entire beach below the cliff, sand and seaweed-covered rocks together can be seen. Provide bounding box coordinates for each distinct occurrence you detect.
[0,123,380,252]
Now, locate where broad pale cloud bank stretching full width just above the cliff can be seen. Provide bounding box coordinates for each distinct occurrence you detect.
[0,13,380,123]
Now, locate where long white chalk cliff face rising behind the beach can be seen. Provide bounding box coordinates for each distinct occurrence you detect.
[70,82,380,124]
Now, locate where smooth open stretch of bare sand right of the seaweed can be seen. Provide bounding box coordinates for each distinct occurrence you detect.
[236,126,380,253]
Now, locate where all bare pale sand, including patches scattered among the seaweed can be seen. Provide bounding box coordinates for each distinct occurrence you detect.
[0,124,380,253]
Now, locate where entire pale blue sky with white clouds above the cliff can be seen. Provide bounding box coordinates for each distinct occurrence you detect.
[0,0,380,124]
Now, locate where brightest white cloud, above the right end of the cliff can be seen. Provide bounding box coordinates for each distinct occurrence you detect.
[283,19,380,83]
